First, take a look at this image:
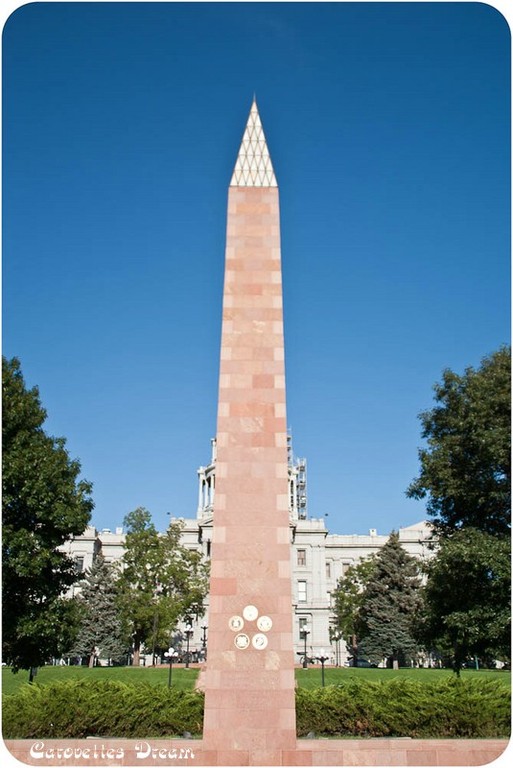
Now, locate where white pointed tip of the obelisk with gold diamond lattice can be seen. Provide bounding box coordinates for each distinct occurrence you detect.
[230,101,278,187]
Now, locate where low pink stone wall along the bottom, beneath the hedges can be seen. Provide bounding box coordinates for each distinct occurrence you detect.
[2,738,509,768]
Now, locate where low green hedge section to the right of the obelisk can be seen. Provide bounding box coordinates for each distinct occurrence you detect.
[296,677,511,738]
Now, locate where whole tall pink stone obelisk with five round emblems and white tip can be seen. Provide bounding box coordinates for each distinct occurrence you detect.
[203,101,296,765]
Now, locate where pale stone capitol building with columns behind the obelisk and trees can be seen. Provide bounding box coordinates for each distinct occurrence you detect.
[61,439,432,666]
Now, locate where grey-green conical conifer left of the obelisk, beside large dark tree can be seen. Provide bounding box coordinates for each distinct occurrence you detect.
[69,553,130,667]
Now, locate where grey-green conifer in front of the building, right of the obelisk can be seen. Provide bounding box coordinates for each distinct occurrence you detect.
[358,532,420,665]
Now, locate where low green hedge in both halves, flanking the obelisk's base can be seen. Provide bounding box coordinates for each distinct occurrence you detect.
[3,678,510,739]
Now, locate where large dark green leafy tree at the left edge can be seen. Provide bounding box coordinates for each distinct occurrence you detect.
[2,358,93,671]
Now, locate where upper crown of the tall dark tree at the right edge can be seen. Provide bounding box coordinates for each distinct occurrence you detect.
[407,347,511,535]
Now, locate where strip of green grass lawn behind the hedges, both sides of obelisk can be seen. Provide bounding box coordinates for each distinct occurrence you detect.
[2,665,511,694]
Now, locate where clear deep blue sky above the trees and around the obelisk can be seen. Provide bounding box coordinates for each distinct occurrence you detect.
[3,3,510,533]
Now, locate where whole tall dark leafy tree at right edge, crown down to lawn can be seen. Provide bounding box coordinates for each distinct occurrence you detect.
[407,347,511,674]
